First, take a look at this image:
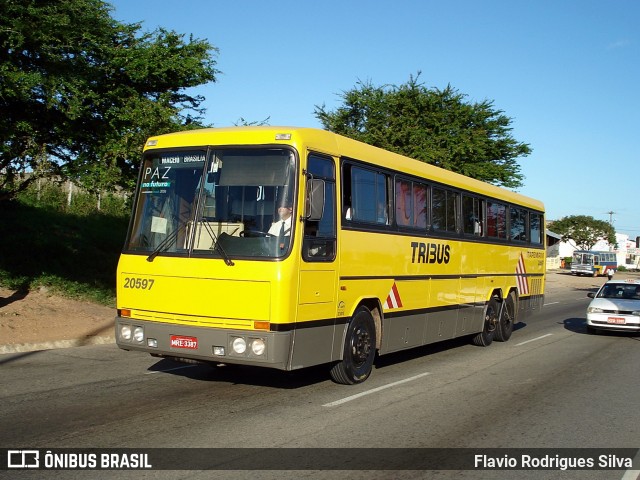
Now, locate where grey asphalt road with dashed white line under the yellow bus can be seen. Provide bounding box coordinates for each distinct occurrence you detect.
[0,282,640,480]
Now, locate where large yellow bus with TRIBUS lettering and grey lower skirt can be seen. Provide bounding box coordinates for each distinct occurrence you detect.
[116,127,545,384]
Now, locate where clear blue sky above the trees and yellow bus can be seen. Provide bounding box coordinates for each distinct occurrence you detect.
[109,0,640,239]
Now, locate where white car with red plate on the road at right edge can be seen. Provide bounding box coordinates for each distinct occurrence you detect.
[587,280,640,333]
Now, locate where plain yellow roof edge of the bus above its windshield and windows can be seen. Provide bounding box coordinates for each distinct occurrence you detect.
[145,126,544,212]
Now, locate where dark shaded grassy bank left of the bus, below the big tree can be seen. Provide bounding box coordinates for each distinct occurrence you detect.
[0,201,128,306]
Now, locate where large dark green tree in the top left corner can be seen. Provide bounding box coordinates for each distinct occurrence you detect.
[0,0,218,199]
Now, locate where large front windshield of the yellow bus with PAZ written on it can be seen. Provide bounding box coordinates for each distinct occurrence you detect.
[125,148,295,264]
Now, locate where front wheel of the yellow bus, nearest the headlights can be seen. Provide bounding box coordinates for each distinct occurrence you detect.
[330,306,376,385]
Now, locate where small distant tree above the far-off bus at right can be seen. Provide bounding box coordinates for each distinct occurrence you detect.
[549,215,616,250]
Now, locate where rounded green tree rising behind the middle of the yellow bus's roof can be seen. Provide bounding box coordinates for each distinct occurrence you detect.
[315,72,531,188]
